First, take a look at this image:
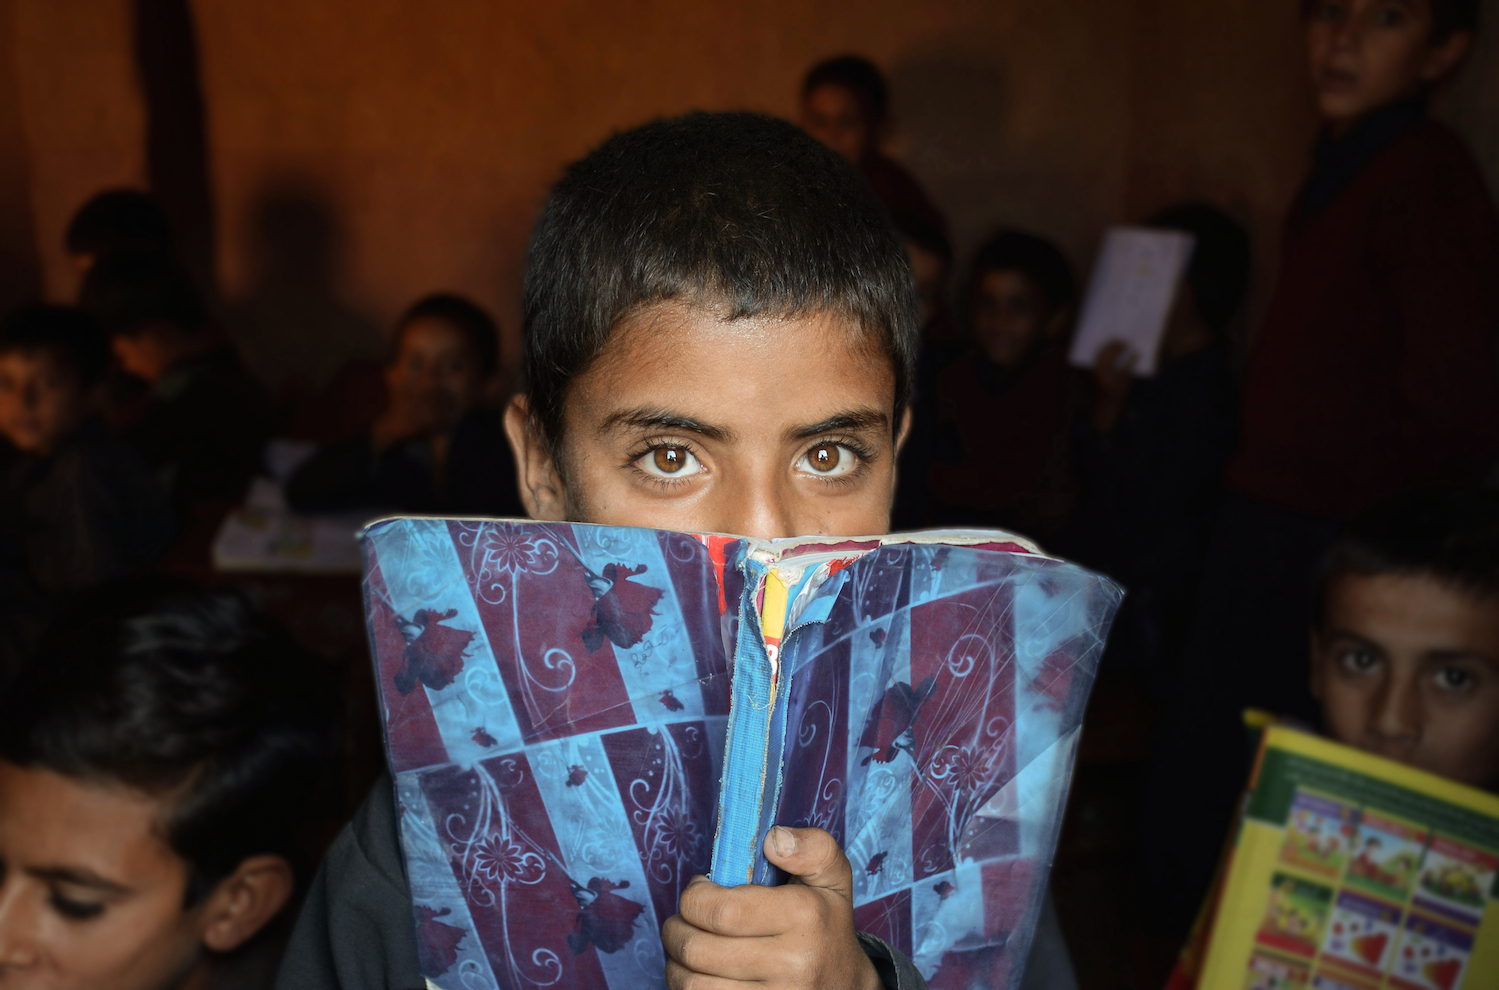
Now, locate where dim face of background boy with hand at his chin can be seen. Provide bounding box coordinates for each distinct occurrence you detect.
[385,317,484,432]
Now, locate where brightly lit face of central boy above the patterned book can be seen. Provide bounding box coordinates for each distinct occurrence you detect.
[507,303,904,539]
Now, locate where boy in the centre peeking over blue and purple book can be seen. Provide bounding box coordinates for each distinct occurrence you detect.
[279,114,923,990]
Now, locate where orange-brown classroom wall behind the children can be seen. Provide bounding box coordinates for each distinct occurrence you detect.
[0,0,1499,380]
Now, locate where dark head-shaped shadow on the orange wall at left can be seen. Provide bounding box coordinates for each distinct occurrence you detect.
[228,183,385,405]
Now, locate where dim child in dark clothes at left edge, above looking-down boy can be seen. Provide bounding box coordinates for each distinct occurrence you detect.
[0,306,172,674]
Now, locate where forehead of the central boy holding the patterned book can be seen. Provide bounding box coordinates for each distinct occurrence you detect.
[565,302,898,438]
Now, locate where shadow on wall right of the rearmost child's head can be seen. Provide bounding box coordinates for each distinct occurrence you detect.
[889,48,1112,272]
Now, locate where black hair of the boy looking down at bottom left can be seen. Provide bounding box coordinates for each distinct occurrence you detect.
[0,581,339,905]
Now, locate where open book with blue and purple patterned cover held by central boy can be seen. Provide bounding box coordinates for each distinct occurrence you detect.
[363,519,1121,990]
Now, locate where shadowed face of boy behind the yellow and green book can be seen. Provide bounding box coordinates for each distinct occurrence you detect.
[1312,575,1499,786]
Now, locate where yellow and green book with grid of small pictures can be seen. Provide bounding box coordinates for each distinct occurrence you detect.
[1196,726,1499,990]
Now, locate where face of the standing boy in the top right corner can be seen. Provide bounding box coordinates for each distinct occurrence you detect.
[1306,0,1469,132]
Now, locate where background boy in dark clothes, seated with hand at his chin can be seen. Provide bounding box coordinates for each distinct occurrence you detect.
[286,294,525,516]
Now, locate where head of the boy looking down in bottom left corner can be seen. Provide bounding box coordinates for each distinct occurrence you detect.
[0,582,339,990]
